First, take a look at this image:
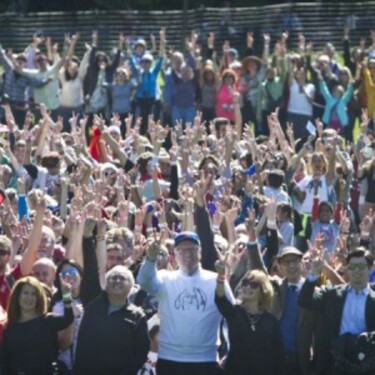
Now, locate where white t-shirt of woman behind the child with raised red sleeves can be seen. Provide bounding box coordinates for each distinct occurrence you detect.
[295,175,332,214]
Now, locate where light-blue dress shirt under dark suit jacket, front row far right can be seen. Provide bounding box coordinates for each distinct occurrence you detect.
[340,285,369,335]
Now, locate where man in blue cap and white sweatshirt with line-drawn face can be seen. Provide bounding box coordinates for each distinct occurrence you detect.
[138,232,233,375]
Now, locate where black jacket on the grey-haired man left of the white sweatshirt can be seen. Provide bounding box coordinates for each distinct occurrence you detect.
[74,292,150,375]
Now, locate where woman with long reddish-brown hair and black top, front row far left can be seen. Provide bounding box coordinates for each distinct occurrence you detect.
[1,276,73,375]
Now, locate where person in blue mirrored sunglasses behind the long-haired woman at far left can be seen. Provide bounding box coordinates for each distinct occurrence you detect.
[52,259,83,374]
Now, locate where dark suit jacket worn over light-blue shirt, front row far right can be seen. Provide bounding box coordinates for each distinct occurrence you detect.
[298,280,375,375]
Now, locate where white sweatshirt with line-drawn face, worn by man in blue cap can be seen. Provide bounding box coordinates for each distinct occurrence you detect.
[151,268,234,362]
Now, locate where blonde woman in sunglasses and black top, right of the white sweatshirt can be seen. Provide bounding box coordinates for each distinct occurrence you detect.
[215,257,283,375]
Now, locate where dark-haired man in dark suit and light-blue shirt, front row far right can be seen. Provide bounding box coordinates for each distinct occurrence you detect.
[298,248,375,375]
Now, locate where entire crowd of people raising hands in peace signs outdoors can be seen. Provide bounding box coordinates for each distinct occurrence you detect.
[0,22,375,375]
